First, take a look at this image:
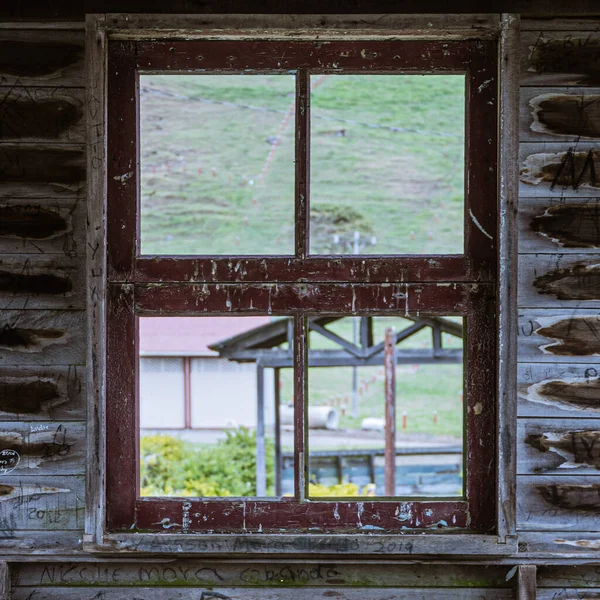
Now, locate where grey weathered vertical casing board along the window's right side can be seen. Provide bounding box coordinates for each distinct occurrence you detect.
[497,14,520,536]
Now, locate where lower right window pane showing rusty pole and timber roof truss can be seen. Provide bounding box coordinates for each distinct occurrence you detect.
[308,317,464,498]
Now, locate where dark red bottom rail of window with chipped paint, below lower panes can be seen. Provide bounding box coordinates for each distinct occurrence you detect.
[136,498,469,533]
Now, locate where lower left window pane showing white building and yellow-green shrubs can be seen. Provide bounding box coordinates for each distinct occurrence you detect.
[139,316,294,497]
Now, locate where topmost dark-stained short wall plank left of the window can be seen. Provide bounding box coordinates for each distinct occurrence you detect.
[0,30,85,87]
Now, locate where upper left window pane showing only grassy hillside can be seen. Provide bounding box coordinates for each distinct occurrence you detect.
[140,75,295,255]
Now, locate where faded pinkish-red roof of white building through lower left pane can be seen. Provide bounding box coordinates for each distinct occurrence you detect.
[140,316,270,356]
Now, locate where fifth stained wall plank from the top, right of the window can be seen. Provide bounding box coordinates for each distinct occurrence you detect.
[519,254,600,308]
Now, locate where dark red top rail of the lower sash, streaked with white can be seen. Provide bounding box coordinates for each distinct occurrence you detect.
[131,283,478,316]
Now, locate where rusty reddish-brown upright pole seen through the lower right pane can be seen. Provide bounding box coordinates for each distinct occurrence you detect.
[383,327,396,496]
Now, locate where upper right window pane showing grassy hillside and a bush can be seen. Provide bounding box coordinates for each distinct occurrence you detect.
[310,75,465,254]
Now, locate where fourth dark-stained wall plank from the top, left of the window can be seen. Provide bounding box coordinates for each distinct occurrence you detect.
[0,198,85,256]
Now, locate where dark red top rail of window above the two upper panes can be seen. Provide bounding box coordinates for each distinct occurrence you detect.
[136,40,495,73]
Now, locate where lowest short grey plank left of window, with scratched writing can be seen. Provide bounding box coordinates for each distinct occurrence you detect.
[0,475,84,538]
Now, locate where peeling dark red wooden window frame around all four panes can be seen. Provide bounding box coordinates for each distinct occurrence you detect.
[89,17,512,553]
